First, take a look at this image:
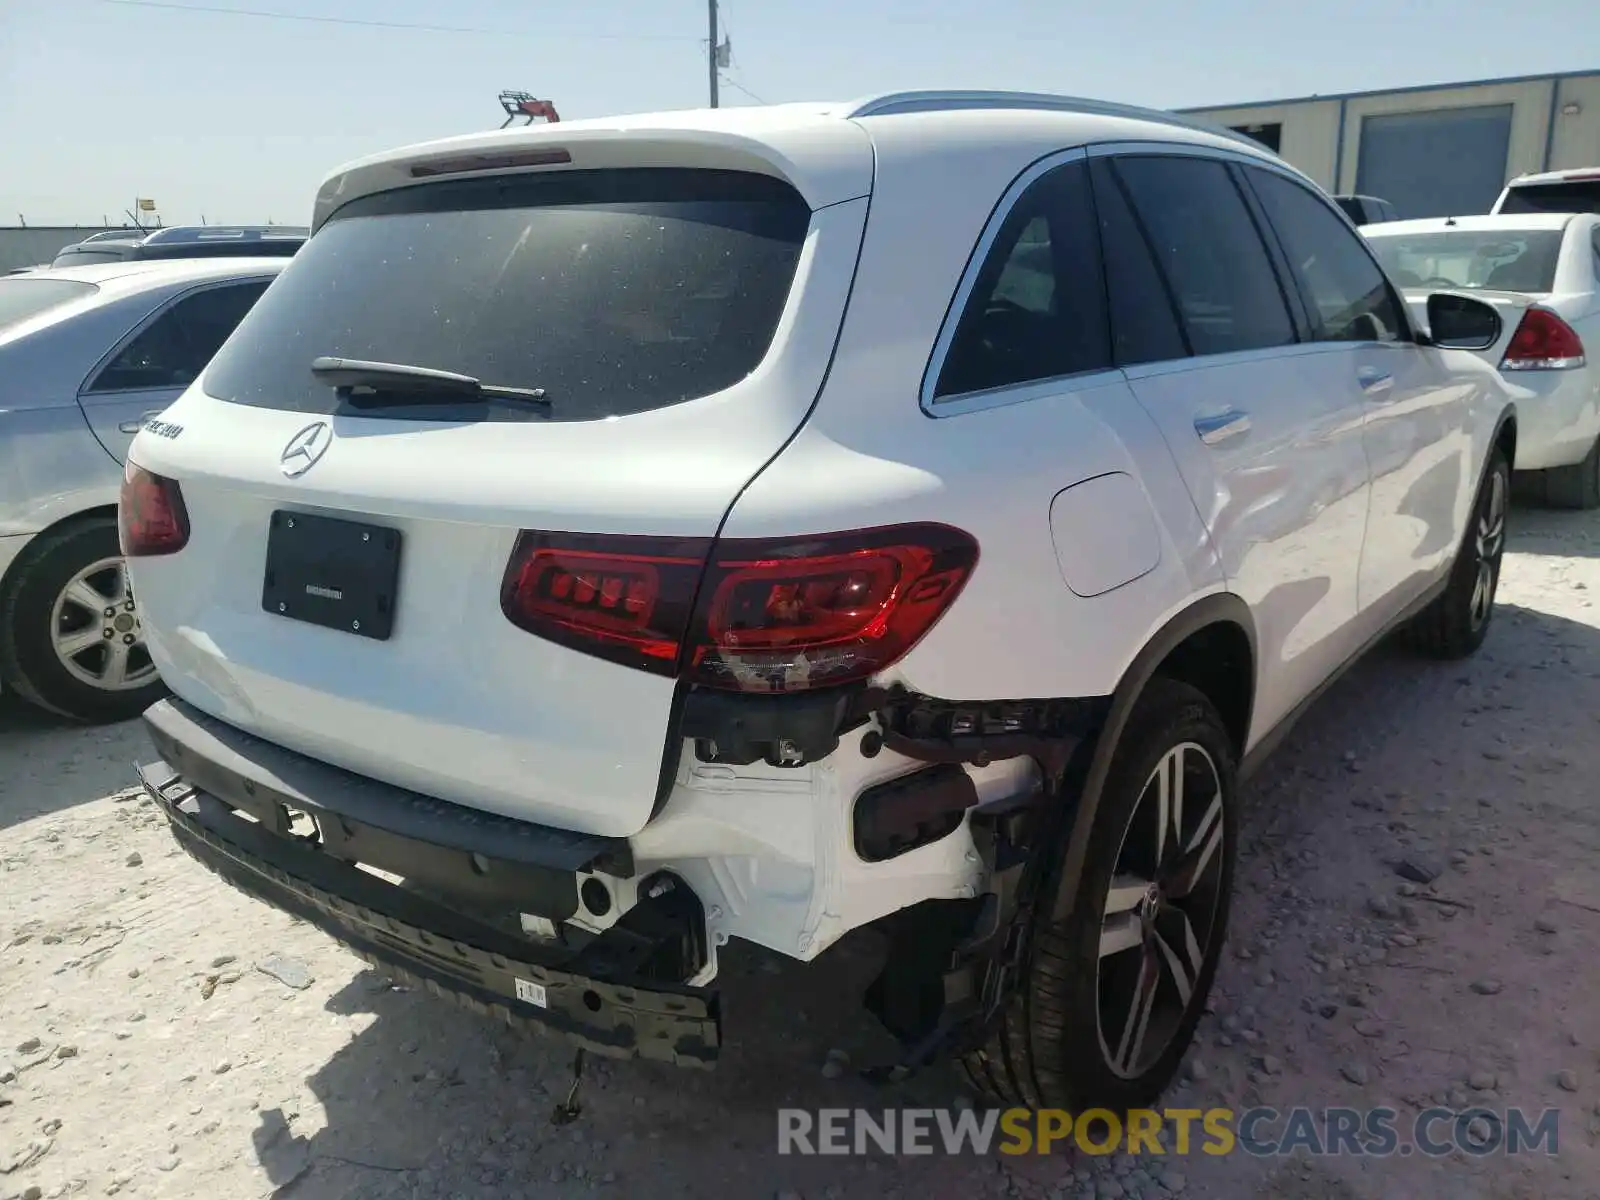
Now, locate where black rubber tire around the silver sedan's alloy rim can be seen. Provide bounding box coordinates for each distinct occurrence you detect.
[0,517,166,723]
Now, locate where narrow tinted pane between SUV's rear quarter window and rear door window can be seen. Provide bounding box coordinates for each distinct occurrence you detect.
[1090,158,1189,366]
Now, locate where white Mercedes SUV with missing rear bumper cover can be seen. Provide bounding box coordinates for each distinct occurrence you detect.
[122,93,1515,1107]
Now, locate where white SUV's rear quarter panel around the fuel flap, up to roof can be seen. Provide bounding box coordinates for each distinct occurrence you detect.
[723,117,1222,699]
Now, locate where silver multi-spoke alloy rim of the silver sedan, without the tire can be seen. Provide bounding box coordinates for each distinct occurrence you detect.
[50,558,157,691]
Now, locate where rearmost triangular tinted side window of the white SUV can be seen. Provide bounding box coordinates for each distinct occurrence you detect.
[934,163,1110,397]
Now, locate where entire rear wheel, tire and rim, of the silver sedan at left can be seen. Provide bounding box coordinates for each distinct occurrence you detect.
[0,517,165,722]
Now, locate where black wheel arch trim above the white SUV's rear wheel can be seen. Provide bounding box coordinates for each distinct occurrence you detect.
[1054,592,1258,920]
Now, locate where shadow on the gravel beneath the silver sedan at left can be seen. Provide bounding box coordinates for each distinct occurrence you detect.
[0,694,154,830]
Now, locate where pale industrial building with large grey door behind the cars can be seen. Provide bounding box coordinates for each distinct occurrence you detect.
[1186,70,1600,218]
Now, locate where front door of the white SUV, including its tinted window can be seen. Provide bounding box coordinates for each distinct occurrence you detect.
[1245,166,1475,620]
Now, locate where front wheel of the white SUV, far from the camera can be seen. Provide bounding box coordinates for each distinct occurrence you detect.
[1408,446,1510,659]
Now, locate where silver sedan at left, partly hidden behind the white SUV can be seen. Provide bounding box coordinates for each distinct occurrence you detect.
[0,259,283,722]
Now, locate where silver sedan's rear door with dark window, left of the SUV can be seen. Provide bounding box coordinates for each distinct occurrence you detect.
[78,278,272,462]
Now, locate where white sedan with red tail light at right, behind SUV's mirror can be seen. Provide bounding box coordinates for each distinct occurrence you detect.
[1362,213,1600,509]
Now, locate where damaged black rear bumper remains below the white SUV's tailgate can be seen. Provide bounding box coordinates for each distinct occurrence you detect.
[139,701,722,1067]
